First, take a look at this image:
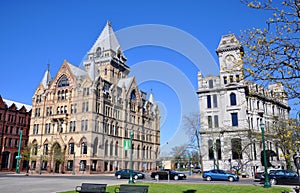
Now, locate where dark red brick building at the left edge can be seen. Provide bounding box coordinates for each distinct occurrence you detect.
[0,96,31,172]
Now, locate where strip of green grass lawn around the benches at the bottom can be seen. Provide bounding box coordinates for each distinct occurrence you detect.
[59,183,292,193]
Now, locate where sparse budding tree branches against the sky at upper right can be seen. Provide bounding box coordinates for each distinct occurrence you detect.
[239,0,300,99]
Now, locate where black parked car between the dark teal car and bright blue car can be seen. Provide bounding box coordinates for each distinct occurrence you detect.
[151,169,186,180]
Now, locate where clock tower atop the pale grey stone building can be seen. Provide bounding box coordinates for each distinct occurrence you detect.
[216,34,244,84]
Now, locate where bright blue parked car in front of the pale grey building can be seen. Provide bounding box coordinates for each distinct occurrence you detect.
[202,169,239,182]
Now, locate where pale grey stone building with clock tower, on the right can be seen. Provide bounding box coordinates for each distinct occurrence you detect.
[197,34,290,175]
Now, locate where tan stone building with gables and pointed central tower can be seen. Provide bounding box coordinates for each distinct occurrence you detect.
[29,22,160,173]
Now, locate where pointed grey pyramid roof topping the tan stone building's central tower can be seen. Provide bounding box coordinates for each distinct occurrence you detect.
[89,21,120,54]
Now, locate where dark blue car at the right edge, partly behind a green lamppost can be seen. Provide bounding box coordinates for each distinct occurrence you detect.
[261,170,299,185]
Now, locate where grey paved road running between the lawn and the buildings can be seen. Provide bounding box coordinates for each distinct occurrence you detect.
[0,173,278,193]
